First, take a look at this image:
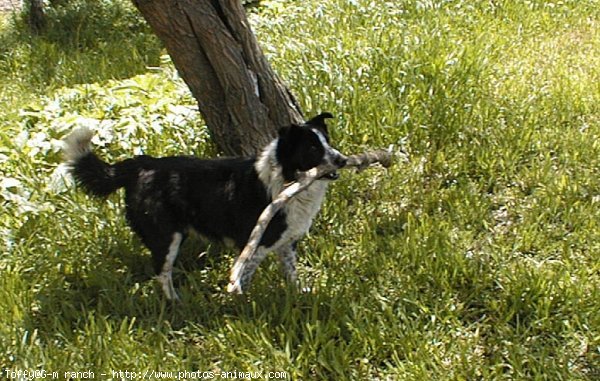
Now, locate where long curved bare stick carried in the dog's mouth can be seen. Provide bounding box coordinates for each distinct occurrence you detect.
[227,150,392,294]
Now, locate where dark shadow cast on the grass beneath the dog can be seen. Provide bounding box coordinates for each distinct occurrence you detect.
[25,238,326,332]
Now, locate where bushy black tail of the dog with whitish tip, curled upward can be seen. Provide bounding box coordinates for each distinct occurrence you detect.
[63,127,132,197]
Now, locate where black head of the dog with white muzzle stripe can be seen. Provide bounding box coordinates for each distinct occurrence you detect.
[276,112,348,181]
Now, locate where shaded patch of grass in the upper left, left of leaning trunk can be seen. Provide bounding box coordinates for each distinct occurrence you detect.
[0,0,162,91]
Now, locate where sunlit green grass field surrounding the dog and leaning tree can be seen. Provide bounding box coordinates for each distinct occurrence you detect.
[0,0,600,380]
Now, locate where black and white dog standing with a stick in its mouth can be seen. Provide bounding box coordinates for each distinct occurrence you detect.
[64,113,347,299]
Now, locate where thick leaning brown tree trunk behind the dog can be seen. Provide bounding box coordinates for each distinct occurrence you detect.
[133,0,302,155]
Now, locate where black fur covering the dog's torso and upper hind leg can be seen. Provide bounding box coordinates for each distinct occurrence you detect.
[117,156,287,272]
